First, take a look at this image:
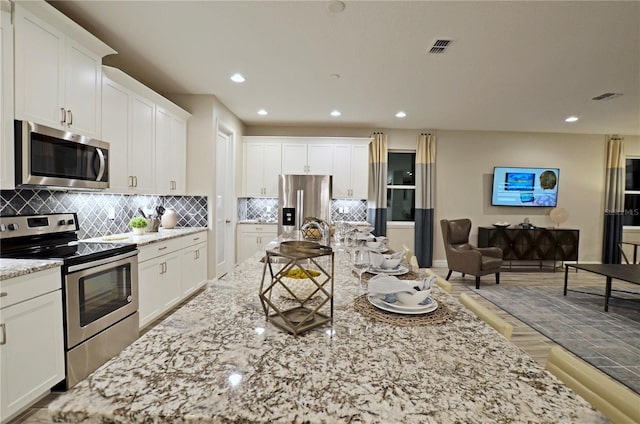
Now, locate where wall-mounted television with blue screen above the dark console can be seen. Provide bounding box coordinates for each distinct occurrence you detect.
[491,166,560,207]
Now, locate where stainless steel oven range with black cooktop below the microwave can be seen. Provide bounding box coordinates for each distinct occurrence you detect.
[0,213,139,388]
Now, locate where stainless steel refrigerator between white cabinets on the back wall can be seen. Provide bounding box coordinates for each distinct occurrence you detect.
[278,175,333,235]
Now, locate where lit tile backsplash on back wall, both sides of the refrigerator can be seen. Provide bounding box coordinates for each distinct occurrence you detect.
[238,197,367,222]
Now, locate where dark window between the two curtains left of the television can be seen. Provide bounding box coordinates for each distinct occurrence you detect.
[387,152,416,222]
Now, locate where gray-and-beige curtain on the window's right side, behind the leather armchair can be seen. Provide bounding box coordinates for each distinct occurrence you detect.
[415,133,436,268]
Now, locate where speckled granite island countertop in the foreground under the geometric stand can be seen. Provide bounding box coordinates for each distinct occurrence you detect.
[49,248,607,424]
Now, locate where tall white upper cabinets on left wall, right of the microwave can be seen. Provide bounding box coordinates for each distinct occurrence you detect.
[101,66,191,195]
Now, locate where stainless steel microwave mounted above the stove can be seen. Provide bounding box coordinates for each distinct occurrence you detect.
[14,120,109,190]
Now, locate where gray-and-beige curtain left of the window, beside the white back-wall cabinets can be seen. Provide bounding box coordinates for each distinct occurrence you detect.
[367,133,387,236]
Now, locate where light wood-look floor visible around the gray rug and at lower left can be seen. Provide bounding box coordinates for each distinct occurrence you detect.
[9,268,637,424]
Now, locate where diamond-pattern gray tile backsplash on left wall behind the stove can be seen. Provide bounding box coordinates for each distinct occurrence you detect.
[0,189,208,239]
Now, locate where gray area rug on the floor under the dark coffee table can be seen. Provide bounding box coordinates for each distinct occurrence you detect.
[474,286,640,393]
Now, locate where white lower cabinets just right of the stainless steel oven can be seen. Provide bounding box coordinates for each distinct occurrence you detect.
[138,232,207,328]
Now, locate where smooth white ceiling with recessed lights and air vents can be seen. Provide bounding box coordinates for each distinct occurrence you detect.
[53,1,640,135]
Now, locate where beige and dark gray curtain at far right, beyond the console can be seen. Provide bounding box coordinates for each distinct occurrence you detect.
[602,135,625,264]
